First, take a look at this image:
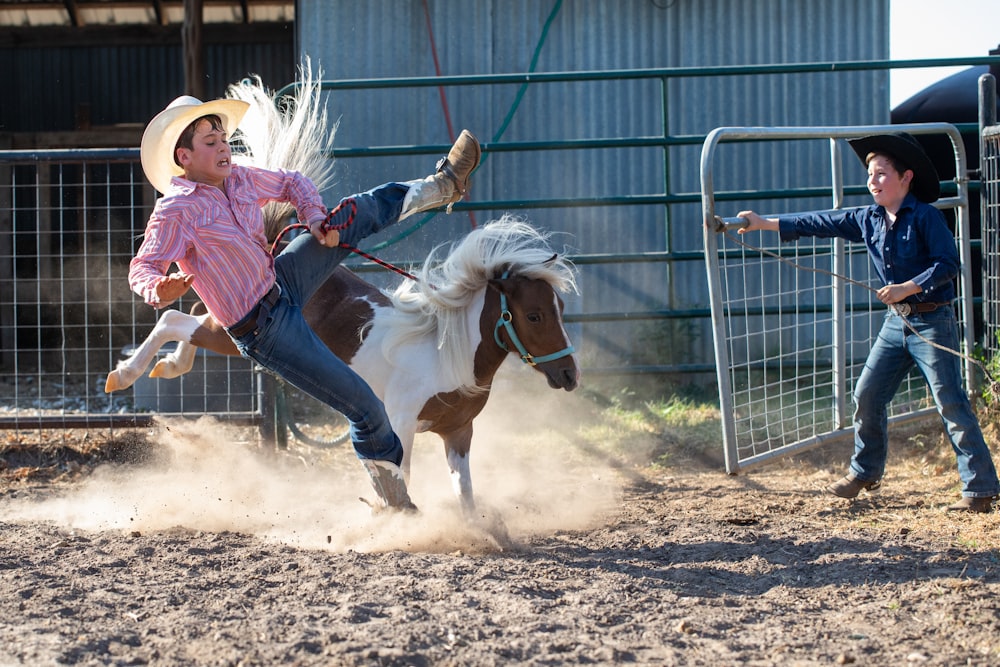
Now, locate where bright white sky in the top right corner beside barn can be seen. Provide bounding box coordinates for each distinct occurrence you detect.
[889,0,1000,107]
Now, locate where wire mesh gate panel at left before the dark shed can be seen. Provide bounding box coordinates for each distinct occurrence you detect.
[0,149,262,440]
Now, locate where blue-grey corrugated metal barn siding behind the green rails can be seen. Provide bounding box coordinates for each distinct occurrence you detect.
[297,0,889,376]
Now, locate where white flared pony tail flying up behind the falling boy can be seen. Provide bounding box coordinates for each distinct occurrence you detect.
[226,56,337,241]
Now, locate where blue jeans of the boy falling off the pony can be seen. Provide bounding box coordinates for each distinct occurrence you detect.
[235,183,408,465]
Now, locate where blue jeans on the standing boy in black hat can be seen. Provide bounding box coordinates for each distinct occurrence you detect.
[851,307,1000,498]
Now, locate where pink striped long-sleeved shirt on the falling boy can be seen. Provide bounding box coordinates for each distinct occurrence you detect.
[128,165,326,326]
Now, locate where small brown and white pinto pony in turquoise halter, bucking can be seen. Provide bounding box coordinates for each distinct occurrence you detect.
[105,216,580,516]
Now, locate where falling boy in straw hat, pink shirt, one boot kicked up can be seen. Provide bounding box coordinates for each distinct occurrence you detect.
[128,96,480,511]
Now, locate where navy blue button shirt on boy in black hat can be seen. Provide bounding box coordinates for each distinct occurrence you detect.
[778,194,959,303]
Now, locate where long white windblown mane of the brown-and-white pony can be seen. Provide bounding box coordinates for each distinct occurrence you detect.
[383,214,577,391]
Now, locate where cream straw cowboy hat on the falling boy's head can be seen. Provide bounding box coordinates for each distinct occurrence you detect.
[139,95,250,193]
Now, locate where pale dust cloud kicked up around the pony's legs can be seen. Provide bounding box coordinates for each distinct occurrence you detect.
[8,367,620,553]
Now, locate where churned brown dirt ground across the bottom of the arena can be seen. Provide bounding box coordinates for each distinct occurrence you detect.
[0,380,1000,666]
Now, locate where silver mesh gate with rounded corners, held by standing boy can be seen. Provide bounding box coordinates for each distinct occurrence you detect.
[701,123,972,473]
